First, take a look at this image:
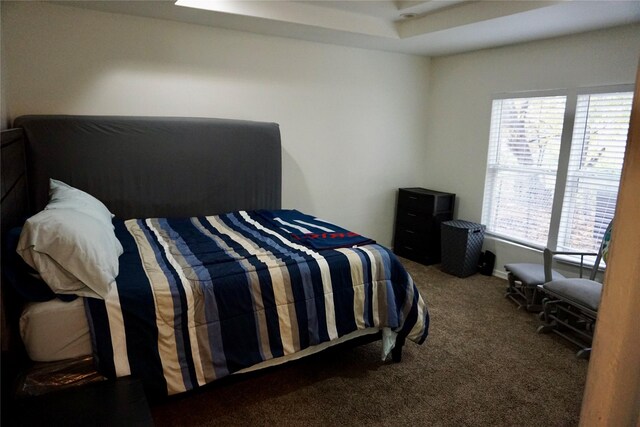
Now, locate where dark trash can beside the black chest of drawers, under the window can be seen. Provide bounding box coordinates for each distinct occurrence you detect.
[440,220,485,277]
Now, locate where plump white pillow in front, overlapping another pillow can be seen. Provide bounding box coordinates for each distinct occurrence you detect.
[17,209,123,298]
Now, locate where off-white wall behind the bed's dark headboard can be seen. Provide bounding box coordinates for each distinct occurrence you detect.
[2,2,429,244]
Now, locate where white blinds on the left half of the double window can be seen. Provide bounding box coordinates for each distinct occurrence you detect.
[482,96,566,246]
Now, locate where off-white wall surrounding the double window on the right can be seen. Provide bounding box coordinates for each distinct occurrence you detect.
[422,25,640,278]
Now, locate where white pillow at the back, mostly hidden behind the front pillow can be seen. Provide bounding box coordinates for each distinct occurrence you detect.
[45,179,114,228]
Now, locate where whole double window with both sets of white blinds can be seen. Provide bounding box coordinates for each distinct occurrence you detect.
[482,87,633,251]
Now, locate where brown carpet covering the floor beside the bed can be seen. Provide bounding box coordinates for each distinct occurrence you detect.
[151,260,588,426]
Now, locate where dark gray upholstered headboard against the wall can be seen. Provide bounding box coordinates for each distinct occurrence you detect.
[14,116,282,219]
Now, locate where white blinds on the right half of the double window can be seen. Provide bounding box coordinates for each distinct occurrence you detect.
[558,92,633,252]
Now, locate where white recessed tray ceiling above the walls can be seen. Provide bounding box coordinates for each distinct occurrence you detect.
[57,0,640,56]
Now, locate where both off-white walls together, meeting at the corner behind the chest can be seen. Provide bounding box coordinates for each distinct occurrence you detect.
[1,2,640,270]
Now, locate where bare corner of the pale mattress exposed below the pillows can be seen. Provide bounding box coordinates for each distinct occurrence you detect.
[20,298,92,362]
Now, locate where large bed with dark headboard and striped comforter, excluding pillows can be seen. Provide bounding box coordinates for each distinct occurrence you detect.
[2,116,429,395]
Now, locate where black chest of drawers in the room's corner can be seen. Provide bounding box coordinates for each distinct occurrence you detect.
[393,188,456,265]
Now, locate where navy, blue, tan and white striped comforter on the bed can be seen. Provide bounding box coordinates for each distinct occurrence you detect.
[82,211,429,394]
